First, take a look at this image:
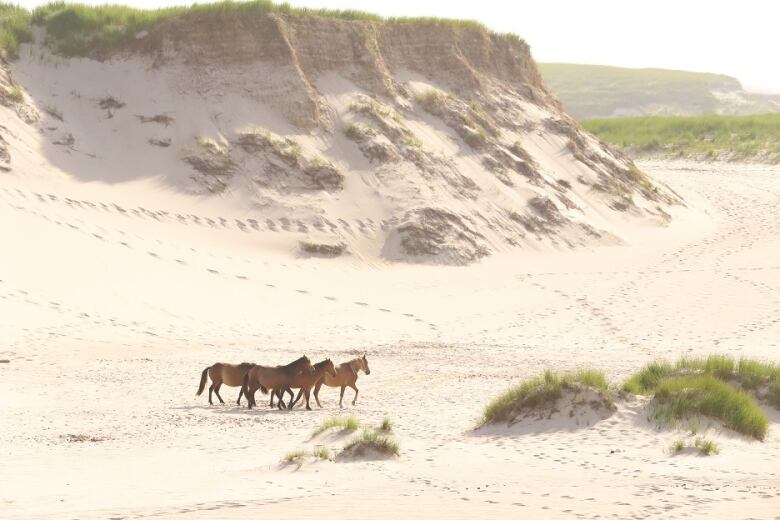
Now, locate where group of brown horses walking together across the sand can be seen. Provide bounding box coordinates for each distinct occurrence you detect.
[196,354,371,410]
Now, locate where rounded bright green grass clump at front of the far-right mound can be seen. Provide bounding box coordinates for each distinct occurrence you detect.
[653,374,769,439]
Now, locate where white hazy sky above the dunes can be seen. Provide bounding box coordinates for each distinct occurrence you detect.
[16,0,780,92]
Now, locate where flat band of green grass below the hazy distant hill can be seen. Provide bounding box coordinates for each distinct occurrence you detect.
[582,114,780,163]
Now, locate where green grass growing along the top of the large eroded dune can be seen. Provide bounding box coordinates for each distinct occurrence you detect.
[0,0,521,56]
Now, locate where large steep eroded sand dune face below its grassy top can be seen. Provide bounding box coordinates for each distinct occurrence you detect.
[0,13,681,264]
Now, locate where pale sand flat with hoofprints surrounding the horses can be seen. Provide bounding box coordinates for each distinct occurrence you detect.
[0,159,780,519]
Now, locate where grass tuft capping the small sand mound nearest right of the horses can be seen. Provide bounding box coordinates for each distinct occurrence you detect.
[479,369,609,425]
